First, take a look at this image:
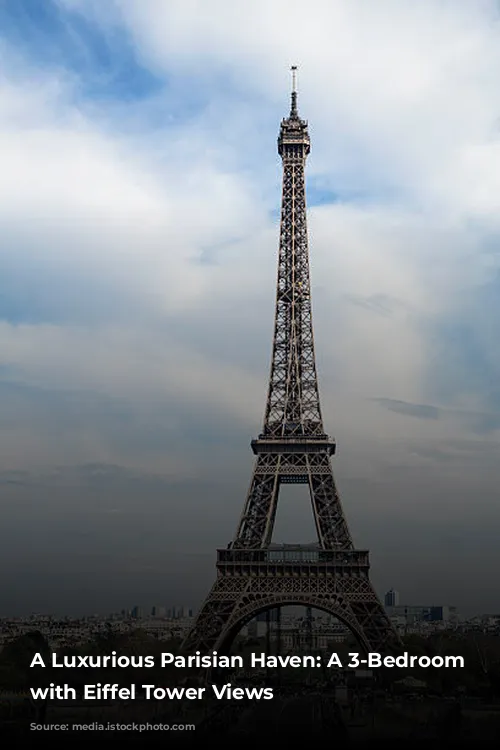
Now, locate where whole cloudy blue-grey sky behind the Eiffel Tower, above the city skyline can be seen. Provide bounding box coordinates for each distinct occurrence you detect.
[0,0,500,616]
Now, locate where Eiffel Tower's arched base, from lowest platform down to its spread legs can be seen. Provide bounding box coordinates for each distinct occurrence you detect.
[182,545,399,654]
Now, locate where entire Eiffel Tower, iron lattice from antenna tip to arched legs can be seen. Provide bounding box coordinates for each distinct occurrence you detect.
[183,66,399,653]
